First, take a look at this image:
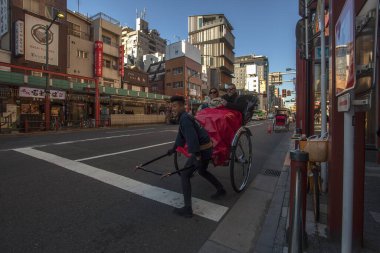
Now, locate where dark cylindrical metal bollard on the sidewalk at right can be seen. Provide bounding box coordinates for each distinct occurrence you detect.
[288,150,309,253]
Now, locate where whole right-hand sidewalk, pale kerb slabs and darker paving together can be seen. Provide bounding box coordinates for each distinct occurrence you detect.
[199,133,380,253]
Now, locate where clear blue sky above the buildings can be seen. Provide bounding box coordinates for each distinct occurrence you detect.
[67,0,299,94]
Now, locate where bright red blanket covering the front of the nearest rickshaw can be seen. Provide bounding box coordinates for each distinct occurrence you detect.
[177,107,242,166]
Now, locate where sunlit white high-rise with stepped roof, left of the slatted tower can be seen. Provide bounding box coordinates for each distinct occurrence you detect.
[121,15,166,69]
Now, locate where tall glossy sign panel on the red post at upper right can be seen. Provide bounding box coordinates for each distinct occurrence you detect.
[335,0,356,96]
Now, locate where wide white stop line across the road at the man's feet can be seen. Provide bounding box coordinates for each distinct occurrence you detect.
[14,148,228,222]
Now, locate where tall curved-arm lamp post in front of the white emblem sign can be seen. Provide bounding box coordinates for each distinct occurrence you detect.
[45,12,65,131]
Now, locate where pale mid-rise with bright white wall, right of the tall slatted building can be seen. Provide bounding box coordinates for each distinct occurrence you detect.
[233,55,270,109]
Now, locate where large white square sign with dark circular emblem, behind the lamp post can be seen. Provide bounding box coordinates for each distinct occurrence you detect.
[25,14,59,66]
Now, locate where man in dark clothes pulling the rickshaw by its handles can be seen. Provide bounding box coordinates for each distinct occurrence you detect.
[168,96,226,217]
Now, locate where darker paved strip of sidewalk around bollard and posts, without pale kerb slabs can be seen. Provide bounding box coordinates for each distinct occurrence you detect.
[252,145,380,253]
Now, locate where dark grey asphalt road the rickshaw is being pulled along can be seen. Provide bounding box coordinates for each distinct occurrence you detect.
[0,121,289,252]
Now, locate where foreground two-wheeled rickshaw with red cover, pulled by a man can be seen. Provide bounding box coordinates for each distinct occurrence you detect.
[136,95,258,192]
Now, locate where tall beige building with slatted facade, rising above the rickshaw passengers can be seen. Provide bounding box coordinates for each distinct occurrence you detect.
[188,14,235,89]
